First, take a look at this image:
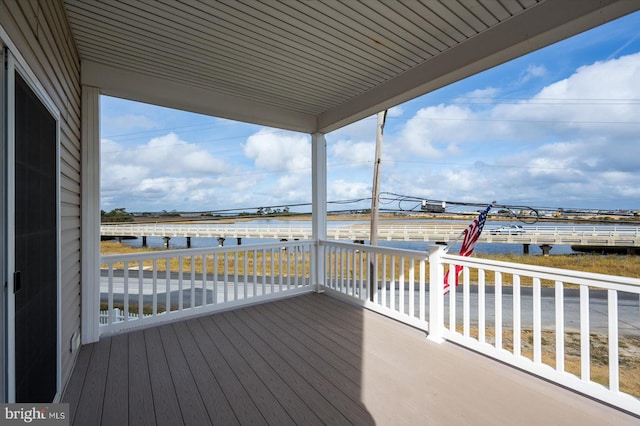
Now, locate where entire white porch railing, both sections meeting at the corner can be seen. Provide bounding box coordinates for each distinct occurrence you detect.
[100,241,640,414]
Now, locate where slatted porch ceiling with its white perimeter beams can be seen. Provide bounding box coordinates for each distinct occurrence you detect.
[64,0,640,133]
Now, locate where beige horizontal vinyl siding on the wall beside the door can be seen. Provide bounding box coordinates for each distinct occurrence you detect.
[0,0,81,392]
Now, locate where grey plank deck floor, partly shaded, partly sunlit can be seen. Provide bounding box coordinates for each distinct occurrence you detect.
[63,294,639,426]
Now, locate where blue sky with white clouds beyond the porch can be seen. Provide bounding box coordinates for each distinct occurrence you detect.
[100,13,640,212]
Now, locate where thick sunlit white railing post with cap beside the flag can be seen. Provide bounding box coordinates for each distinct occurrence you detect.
[427,245,444,343]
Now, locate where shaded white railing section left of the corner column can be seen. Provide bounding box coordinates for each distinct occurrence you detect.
[100,241,315,334]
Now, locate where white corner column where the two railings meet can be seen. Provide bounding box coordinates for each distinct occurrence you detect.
[311,133,327,291]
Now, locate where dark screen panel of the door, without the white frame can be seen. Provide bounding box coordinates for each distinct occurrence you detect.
[14,73,58,402]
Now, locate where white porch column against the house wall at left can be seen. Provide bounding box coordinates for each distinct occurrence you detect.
[81,86,100,344]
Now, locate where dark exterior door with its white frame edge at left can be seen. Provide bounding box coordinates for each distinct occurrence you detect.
[3,50,59,402]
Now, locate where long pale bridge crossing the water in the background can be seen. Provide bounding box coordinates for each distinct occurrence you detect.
[100,222,640,251]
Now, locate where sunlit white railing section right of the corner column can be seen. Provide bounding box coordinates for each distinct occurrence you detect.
[320,241,640,414]
